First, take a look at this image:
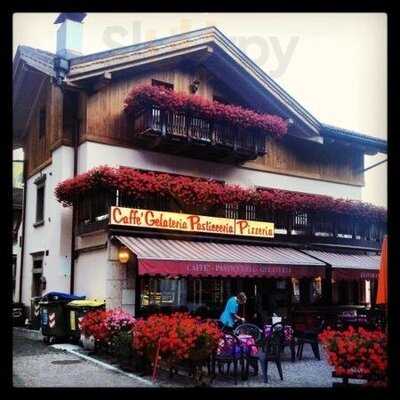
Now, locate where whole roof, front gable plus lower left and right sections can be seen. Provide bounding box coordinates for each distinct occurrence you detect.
[14,27,386,152]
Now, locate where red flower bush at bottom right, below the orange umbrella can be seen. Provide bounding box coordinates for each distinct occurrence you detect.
[319,326,388,382]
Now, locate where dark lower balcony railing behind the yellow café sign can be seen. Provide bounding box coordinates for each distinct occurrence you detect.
[77,191,386,249]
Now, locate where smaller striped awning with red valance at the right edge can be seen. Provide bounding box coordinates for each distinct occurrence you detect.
[305,250,380,281]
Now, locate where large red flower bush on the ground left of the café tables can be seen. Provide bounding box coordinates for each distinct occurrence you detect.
[133,313,222,366]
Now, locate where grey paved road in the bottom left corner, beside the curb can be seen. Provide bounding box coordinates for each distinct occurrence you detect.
[13,335,155,387]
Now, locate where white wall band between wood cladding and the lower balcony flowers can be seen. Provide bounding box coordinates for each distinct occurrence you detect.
[78,142,361,200]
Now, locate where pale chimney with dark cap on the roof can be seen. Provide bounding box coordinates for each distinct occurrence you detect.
[54,13,86,60]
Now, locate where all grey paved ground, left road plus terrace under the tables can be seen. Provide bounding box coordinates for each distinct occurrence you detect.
[13,335,344,388]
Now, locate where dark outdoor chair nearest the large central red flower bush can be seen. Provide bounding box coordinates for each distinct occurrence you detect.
[211,333,244,385]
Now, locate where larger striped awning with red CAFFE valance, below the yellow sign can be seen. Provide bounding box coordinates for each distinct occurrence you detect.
[116,236,325,278]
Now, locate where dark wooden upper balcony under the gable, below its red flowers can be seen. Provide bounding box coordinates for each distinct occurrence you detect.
[132,106,266,164]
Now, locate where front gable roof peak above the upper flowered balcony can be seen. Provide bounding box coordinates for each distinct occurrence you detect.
[67,27,319,137]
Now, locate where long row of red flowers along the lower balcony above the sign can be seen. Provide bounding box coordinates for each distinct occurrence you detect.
[55,166,386,222]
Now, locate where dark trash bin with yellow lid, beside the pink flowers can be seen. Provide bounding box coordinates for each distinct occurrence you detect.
[67,300,106,342]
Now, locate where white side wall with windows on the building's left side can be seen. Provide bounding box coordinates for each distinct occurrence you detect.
[16,146,73,305]
